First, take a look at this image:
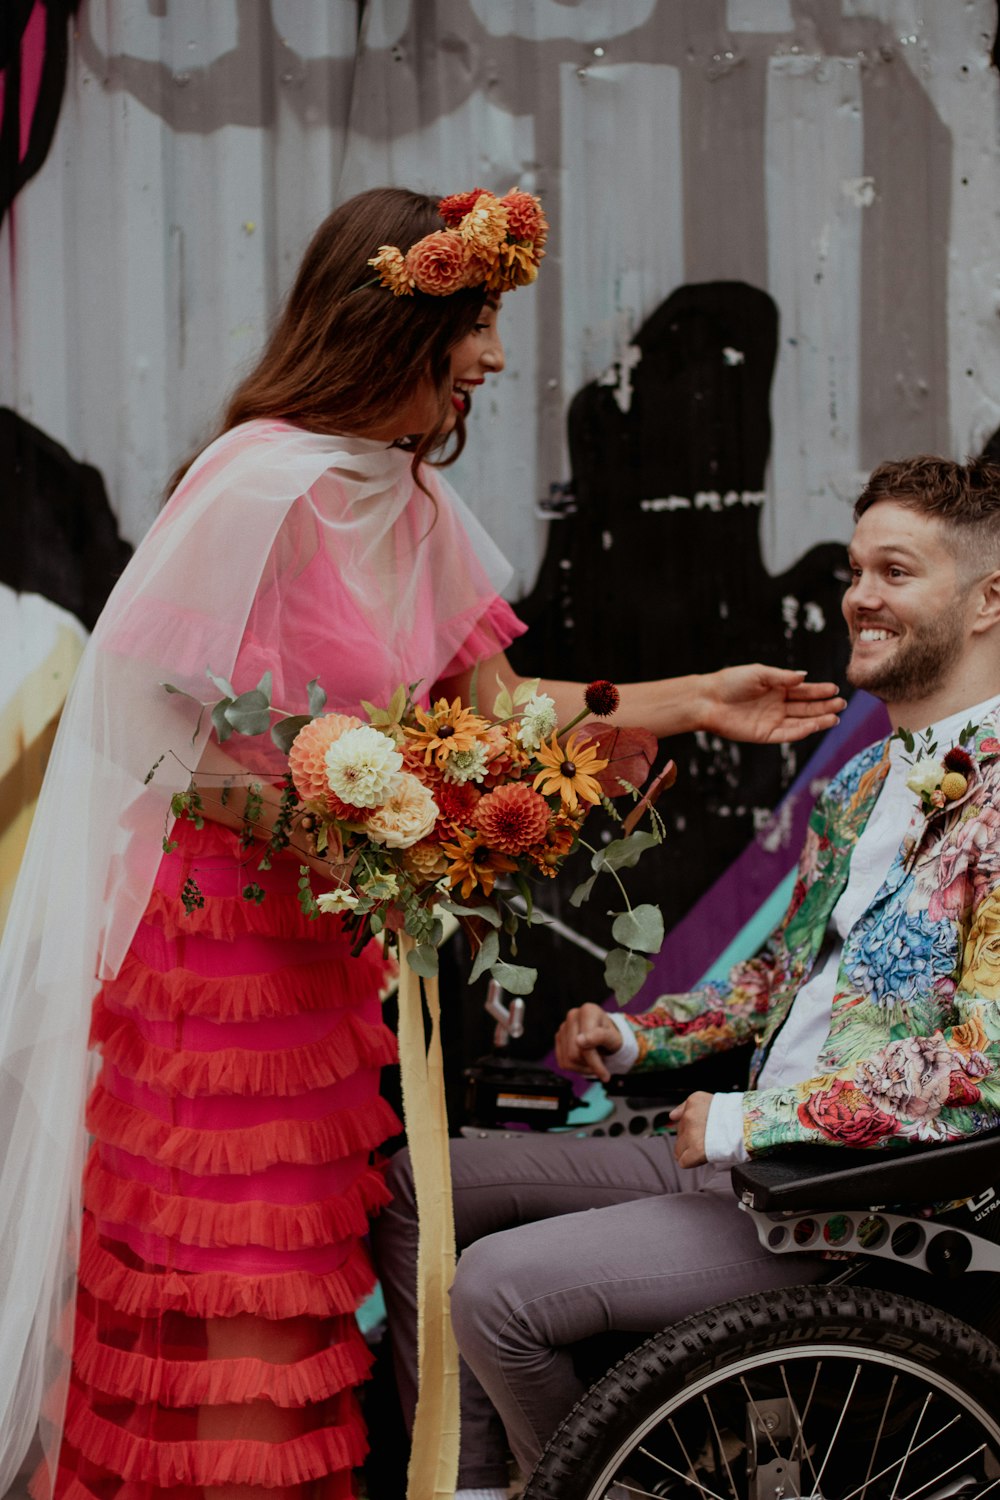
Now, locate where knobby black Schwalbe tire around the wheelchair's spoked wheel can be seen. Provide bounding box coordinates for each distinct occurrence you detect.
[523,1286,1000,1500]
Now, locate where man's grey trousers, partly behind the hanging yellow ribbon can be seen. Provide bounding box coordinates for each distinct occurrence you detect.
[372,1133,823,1488]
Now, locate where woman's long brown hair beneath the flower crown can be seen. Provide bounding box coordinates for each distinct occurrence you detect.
[171,188,484,491]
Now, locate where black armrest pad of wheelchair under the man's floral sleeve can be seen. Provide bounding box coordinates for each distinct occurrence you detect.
[732,1128,1000,1214]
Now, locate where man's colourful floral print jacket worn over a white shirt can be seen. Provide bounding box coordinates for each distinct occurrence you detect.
[630,716,1000,1155]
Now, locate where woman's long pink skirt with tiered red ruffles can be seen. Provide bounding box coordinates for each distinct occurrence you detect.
[40,824,400,1500]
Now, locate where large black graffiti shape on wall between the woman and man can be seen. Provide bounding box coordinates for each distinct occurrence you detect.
[500,282,846,1055]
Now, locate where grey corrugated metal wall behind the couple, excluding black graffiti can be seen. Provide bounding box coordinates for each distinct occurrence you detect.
[0,0,1000,593]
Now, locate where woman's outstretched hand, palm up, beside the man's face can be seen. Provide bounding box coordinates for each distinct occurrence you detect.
[699,663,847,746]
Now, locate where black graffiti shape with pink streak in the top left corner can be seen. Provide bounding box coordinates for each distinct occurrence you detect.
[0,0,79,224]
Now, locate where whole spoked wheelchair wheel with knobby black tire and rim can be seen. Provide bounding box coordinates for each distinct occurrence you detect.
[523,1286,1000,1500]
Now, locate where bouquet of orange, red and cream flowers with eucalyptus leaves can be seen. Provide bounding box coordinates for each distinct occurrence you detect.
[163,672,673,1004]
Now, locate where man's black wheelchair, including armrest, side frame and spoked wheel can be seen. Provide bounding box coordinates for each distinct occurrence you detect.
[523,1130,1000,1500]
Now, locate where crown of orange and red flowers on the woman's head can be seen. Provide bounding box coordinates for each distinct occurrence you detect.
[369,188,549,297]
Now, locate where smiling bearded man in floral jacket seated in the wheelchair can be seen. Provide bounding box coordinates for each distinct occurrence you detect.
[375,458,1000,1500]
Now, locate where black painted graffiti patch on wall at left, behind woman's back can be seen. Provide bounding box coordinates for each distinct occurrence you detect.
[0,407,132,630]
